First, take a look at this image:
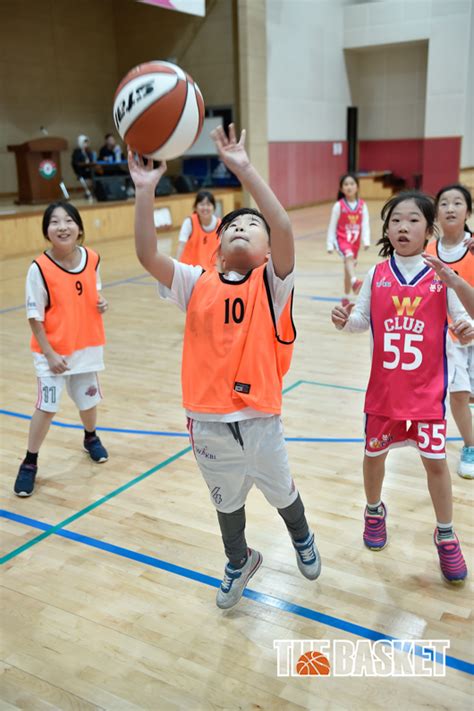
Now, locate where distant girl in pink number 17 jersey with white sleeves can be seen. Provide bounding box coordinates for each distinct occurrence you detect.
[327,173,370,306]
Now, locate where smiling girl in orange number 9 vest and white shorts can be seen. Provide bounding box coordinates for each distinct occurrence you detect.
[14,202,108,496]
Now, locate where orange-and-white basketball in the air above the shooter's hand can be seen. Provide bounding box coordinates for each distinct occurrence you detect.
[113,61,204,160]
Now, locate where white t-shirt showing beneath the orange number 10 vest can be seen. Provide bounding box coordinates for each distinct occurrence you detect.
[158,258,295,422]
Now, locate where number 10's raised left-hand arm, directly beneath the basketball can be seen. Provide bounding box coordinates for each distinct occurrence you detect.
[128,149,174,289]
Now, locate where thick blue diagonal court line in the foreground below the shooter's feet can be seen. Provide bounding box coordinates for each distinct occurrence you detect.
[0,509,474,675]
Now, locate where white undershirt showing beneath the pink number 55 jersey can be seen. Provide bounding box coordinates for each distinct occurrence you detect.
[343,254,471,342]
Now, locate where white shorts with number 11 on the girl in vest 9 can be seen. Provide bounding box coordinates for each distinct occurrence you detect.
[36,373,102,412]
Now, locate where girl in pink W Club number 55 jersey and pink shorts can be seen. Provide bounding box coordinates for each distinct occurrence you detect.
[332,191,471,583]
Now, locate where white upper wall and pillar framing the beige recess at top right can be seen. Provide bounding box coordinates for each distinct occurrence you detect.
[344,0,474,165]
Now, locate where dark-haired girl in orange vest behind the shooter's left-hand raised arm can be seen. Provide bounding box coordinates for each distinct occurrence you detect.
[176,190,220,269]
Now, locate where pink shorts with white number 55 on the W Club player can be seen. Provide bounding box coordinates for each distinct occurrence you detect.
[365,415,446,459]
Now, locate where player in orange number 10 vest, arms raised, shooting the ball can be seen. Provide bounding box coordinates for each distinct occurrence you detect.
[128,125,321,608]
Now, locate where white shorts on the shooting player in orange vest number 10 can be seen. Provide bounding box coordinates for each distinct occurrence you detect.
[188,415,298,513]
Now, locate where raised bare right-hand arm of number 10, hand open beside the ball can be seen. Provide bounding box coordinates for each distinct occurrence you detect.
[211,123,295,279]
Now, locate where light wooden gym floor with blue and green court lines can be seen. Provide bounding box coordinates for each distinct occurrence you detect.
[0,203,474,711]
